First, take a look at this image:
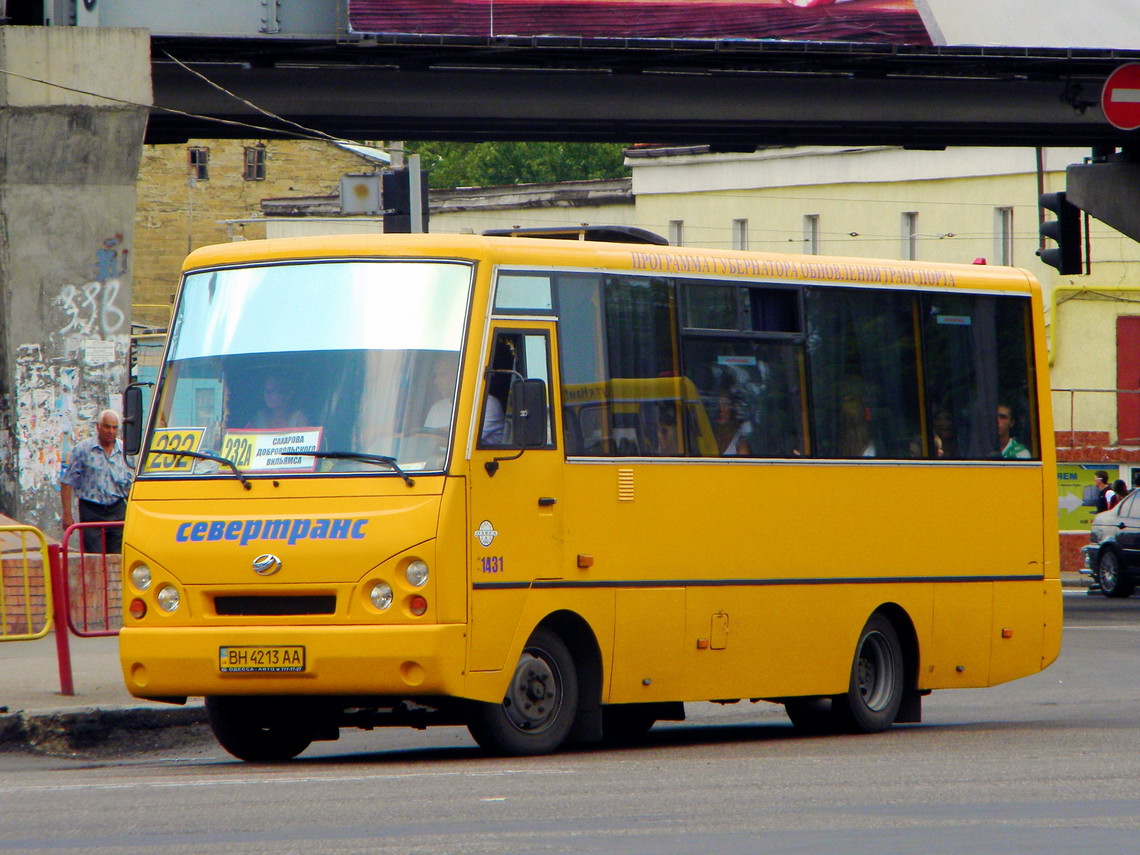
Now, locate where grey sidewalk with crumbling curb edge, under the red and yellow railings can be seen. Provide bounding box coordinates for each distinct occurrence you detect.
[0,634,205,754]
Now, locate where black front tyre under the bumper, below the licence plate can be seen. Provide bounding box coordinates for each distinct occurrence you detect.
[205,697,317,763]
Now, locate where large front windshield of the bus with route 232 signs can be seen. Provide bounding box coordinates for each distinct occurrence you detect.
[143,260,472,477]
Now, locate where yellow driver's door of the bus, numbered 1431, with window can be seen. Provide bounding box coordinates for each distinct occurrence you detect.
[469,320,564,670]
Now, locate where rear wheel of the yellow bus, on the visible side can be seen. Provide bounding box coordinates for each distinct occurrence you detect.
[831,613,905,733]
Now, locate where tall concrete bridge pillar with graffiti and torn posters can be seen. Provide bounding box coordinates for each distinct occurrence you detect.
[0,26,150,531]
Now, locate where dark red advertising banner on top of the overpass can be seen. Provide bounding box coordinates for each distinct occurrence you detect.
[348,0,931,44]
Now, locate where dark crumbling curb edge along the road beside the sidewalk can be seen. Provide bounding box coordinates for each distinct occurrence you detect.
[0,706,206,754]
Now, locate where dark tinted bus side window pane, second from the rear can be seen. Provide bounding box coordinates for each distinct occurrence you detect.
[805,288,933,457]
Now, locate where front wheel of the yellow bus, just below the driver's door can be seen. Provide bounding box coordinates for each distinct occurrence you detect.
[467,627,578,757]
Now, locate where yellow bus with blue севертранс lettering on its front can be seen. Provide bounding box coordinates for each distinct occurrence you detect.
[120,231,1061,760]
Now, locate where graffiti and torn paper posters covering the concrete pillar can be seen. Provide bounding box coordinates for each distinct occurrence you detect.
[14,235,130,526]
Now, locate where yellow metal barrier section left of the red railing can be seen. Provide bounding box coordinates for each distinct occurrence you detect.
[0,526,52,642]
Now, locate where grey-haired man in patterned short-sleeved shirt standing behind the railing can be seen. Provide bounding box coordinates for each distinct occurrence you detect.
[59,409,133,553]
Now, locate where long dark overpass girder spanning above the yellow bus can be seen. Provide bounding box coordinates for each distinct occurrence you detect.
[147,36,1140,149]
